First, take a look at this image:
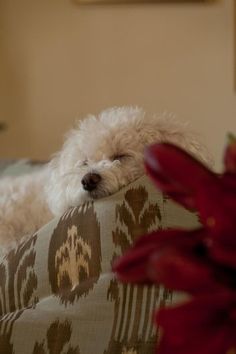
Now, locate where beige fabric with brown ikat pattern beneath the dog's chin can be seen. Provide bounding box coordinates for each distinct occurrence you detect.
[0,165,197,354]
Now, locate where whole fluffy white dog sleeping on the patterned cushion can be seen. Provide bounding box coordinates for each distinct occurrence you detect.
[0,107,208,252]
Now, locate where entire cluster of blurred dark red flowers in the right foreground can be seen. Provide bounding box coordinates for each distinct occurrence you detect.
[113,137,236,354]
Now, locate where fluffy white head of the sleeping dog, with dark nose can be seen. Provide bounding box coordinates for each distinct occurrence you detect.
[46,107,210,214]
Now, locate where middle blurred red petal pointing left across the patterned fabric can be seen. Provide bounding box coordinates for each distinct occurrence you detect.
[113,229,236,295]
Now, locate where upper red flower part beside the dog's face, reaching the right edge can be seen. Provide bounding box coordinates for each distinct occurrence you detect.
[145,144,236,233]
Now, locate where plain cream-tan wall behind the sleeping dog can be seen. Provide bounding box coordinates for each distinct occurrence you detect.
[0,0,236,169]
